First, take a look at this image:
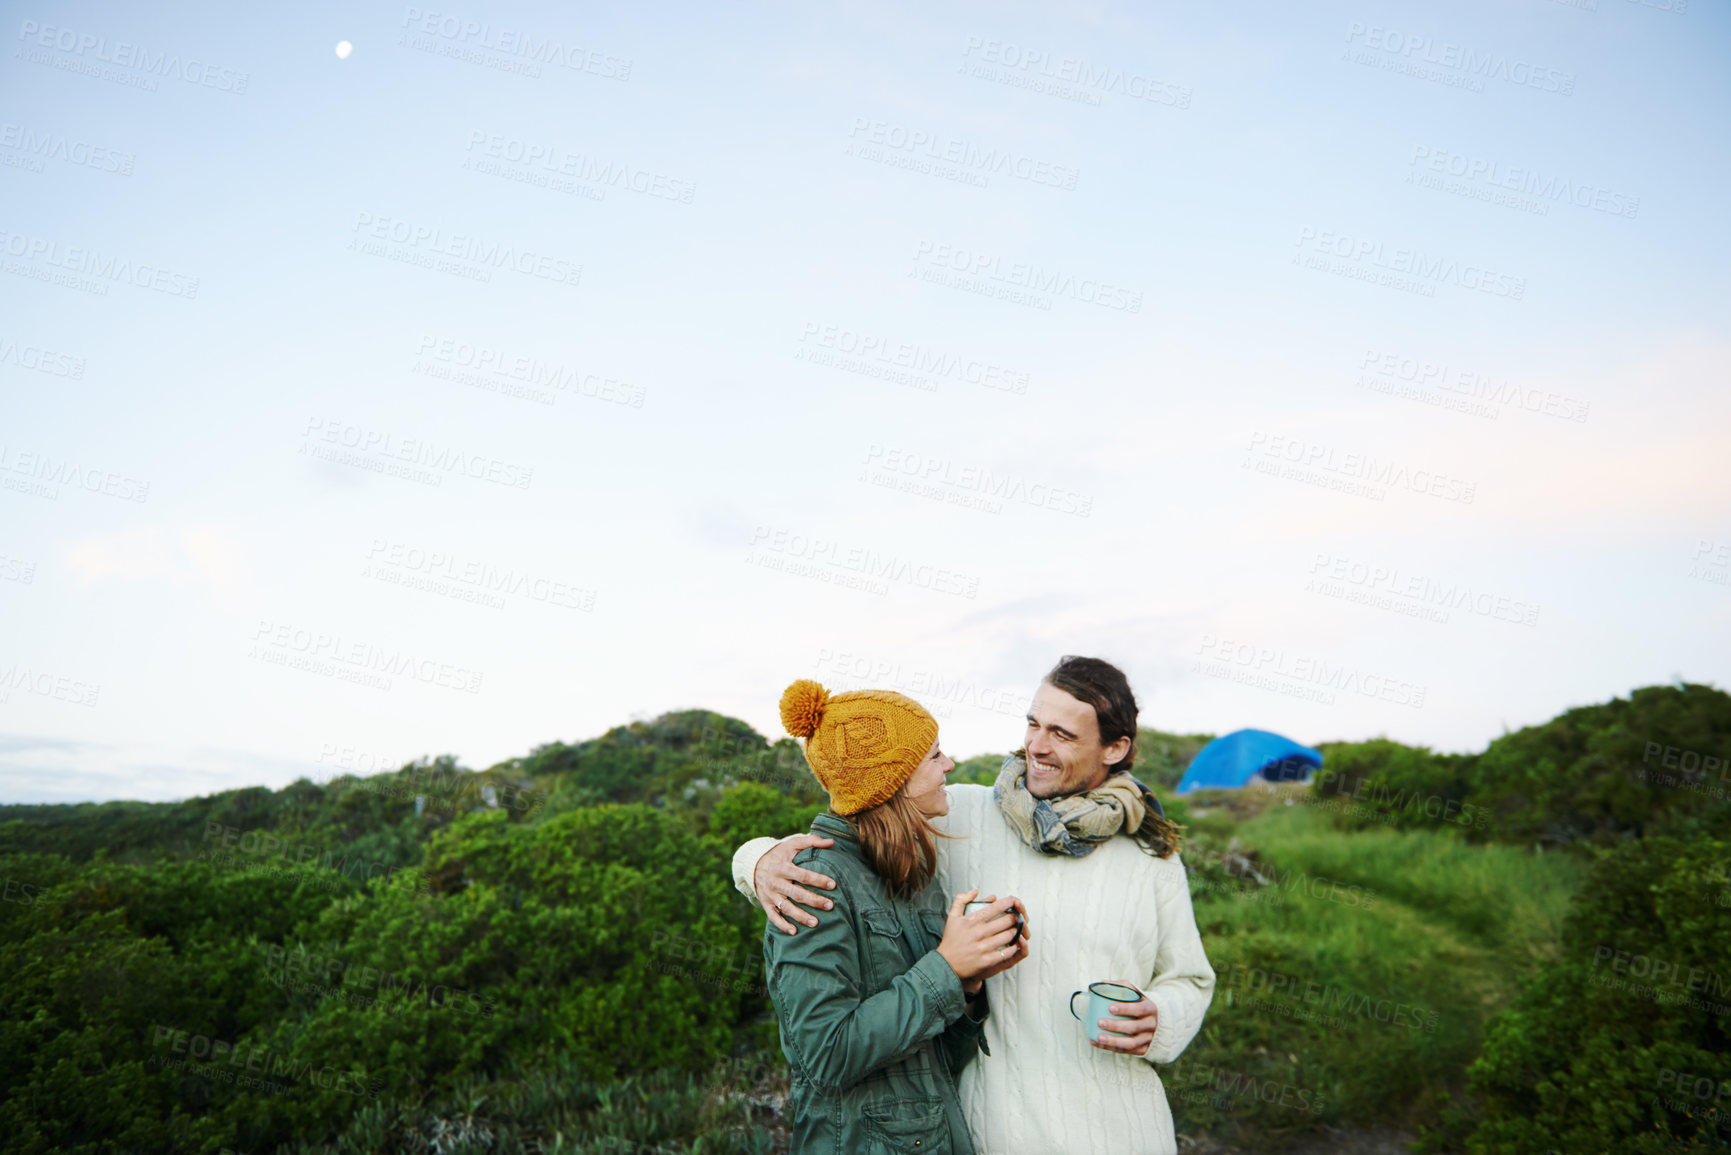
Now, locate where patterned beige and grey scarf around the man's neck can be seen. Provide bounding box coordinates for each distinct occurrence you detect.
[992,753,1179,859]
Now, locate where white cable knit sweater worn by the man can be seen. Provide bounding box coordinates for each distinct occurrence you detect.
[734,784,1213,1155]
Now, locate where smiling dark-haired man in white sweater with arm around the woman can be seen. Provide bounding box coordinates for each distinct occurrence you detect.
[734,658,1213,1155]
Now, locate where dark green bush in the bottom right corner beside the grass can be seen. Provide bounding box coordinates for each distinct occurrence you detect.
[1426,838,1731,1155]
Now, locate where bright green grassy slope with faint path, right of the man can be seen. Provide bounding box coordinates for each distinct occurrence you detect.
[1163,805,1584,1152]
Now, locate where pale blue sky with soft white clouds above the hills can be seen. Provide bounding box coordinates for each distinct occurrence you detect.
[0,0,1731,802]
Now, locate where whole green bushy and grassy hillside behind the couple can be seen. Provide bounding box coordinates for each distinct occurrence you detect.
[0,686,1731,1155]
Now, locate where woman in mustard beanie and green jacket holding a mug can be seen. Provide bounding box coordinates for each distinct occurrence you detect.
[763,681,1028,1155]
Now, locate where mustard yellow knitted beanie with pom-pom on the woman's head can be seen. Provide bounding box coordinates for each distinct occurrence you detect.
[781,679,938,814]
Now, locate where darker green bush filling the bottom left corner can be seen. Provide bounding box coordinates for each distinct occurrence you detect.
[0,855,360,1153]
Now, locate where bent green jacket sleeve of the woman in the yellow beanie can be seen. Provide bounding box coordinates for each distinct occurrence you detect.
[763,862,962,1094]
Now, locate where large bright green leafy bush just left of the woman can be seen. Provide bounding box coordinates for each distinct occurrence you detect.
[212,805,763,1146]
